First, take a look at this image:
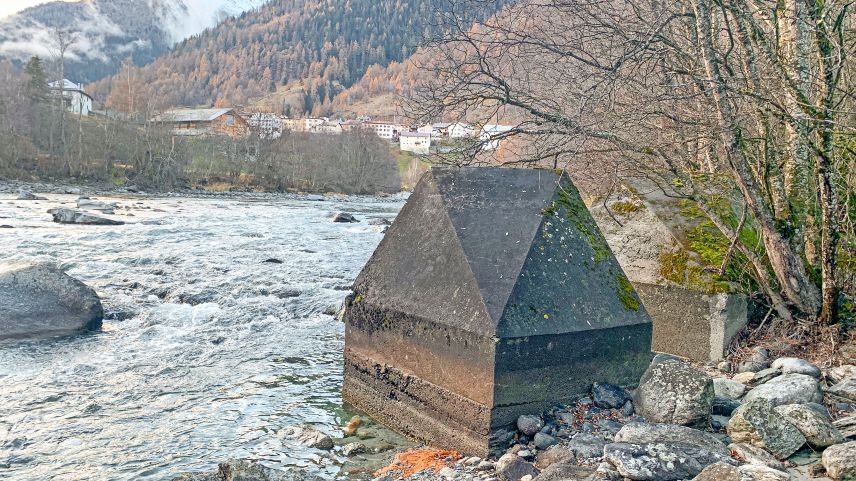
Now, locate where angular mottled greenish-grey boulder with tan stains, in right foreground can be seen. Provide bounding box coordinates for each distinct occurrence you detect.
[728,398,806,459]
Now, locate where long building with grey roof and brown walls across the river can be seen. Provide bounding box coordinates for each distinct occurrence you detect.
[153,109,250,138]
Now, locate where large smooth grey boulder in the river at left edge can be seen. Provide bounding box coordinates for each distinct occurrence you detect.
[0,263,104,339]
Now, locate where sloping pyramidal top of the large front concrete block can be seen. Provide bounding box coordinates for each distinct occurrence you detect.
[354,167,650,338]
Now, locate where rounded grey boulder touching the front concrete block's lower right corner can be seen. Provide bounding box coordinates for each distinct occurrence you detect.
[633,361,714,426]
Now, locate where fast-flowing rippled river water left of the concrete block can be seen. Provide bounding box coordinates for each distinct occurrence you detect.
[0,194,403,481]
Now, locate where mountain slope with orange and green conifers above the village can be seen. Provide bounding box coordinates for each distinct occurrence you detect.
[89,0,506,114]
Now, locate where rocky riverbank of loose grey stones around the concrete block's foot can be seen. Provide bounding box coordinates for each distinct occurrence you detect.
[181,350,856,481]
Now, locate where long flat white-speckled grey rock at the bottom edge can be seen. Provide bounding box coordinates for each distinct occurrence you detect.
[603,443,737,481]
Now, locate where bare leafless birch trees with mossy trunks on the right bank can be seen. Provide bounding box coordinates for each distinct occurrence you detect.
[412,0,856,322]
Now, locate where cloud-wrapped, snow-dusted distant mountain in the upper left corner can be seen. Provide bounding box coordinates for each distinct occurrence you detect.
[0,0,266,83]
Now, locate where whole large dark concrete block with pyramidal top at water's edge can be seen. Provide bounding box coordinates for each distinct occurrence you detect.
[343,168,651,456]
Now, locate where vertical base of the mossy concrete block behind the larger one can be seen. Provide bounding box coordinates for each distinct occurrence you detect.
[634,283,749,362]
